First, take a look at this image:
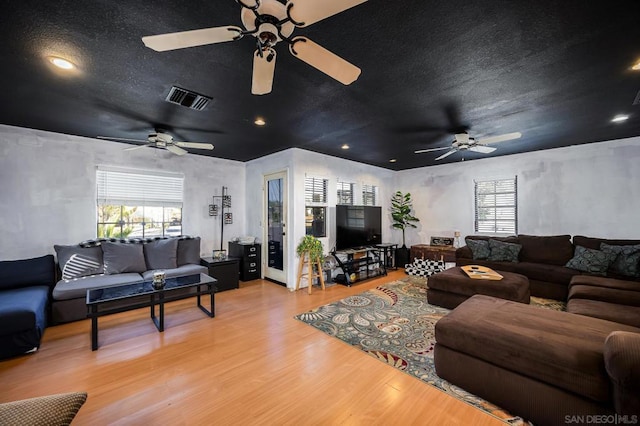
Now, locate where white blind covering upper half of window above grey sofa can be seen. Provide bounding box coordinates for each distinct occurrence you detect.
[96,167,184,208]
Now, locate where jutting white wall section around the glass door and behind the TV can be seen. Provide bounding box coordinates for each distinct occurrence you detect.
[246,148,399,288]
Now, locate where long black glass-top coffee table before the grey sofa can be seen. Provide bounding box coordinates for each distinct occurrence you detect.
[87,274,217,351]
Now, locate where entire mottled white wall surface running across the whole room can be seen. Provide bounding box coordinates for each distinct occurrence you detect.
[0,125,640,282]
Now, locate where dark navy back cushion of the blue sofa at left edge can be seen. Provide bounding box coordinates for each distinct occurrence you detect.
[0,254,56,290]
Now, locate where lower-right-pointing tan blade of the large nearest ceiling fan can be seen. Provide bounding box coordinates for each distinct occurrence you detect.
[289,37,361,85]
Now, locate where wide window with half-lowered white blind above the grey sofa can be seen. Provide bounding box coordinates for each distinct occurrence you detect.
[96,166,184,238]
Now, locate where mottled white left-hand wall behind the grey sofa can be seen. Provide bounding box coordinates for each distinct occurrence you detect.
[0,125,246,260]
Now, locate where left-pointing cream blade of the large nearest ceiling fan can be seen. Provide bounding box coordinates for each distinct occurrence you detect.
[142,26,242,52]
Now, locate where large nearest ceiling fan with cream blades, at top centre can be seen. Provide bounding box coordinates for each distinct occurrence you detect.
[142,0,367,95]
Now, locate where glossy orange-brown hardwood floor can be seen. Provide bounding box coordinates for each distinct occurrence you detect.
[0,271,503,425]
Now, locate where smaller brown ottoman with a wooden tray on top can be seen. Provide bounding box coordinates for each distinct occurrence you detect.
[427,267,530,309]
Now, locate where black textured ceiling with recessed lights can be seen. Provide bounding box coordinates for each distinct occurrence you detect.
[0,0,640,170]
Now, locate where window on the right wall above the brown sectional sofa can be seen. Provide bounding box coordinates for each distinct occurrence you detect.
[475,177,518,235]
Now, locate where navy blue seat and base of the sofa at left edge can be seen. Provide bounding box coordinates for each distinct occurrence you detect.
[0,286,49,358]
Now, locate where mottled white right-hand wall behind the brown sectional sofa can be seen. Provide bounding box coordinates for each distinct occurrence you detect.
[396,137,640,246]
